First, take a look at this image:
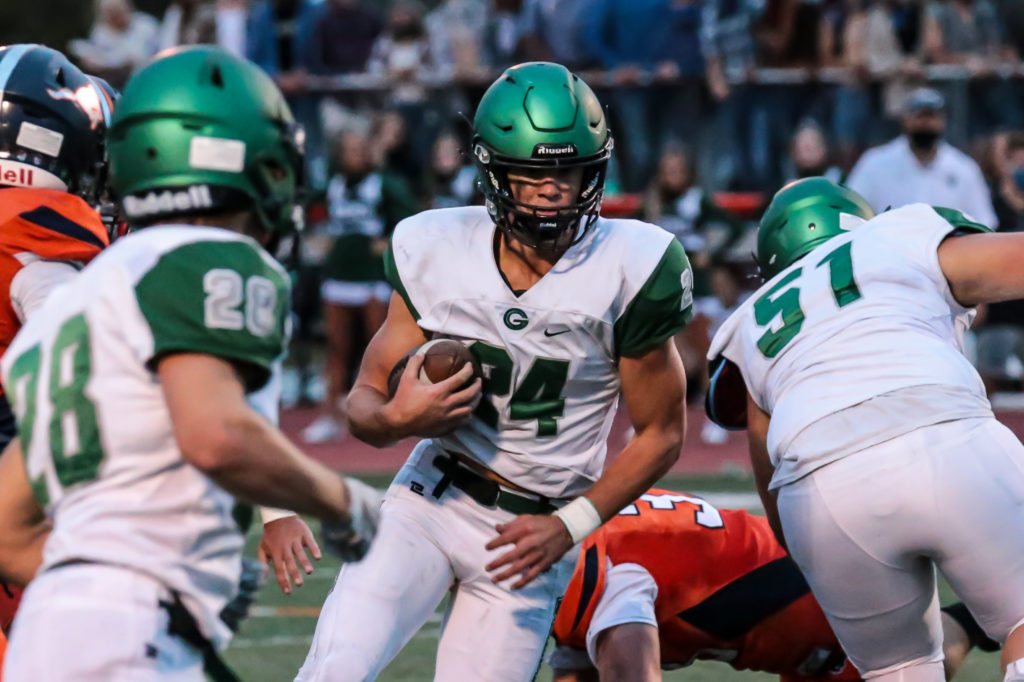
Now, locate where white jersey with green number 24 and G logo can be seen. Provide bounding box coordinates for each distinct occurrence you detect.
[385,207,693,498]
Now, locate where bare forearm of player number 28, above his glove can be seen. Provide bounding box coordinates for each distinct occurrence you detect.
[195,413,348,520]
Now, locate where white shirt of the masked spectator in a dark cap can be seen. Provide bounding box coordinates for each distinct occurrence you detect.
[846,135,997,229]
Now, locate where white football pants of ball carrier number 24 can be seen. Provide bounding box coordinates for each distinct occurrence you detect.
[296,447,578,682]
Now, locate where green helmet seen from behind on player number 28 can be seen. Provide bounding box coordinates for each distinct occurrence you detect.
[109,46,303,237]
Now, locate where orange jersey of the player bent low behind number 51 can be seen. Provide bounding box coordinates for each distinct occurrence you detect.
[554,489,859,682]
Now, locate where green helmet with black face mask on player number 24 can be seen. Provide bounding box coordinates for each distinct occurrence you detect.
[472,61,612,248]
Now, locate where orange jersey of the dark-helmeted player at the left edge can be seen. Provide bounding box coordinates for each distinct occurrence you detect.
[0,187,110,364]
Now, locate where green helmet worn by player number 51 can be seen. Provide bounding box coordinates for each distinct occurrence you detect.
[758,177,874,280]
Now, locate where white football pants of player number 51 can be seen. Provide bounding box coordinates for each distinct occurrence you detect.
[778,419,1024,680]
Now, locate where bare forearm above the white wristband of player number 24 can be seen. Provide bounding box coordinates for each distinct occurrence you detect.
[586,416,686,521]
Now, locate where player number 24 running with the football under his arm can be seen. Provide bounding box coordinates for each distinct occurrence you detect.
[298,62,692,682]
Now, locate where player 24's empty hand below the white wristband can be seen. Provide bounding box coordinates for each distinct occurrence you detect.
[486,514,572,590]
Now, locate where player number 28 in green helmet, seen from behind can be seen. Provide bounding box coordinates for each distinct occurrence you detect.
[0,47,368,682]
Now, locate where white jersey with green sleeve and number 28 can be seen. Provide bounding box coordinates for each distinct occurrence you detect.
[2,226,290,644]
